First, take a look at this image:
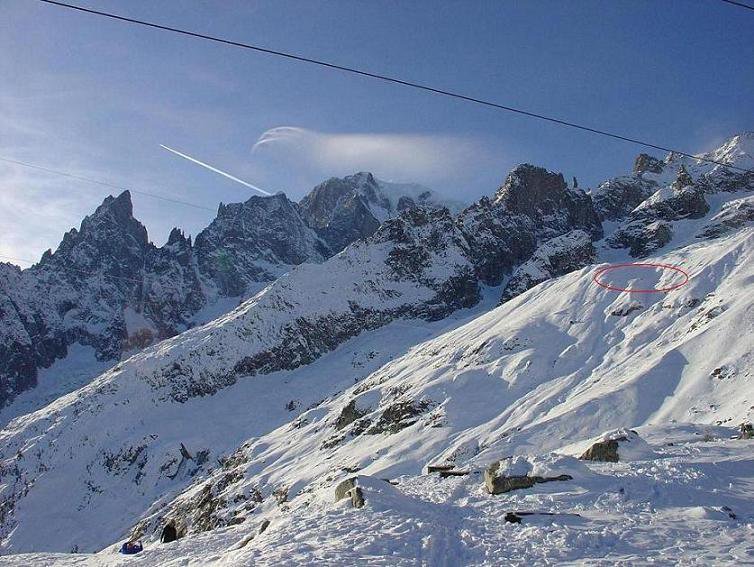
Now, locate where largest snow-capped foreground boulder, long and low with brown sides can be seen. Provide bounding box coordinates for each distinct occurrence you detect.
[484,453,586,494]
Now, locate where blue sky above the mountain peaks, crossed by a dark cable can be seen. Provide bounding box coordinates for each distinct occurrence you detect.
[0,0,754,259]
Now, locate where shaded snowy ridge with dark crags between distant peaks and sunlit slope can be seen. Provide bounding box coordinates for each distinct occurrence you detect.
[0,159,598,551]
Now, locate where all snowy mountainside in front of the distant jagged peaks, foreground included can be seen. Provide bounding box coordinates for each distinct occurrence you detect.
[0,135,754,565]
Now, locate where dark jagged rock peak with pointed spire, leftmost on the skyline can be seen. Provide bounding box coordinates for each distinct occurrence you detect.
[0,191,153,405]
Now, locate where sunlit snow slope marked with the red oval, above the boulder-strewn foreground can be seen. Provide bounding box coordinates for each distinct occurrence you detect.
[132,228,754,540]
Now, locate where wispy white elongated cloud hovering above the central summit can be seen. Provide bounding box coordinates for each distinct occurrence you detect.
[252,126,489,184]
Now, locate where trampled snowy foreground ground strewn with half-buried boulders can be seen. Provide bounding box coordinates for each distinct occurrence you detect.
[0,425,754,567]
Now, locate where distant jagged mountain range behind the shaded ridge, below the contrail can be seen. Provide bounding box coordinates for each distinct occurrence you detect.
[0,174,462,423]
